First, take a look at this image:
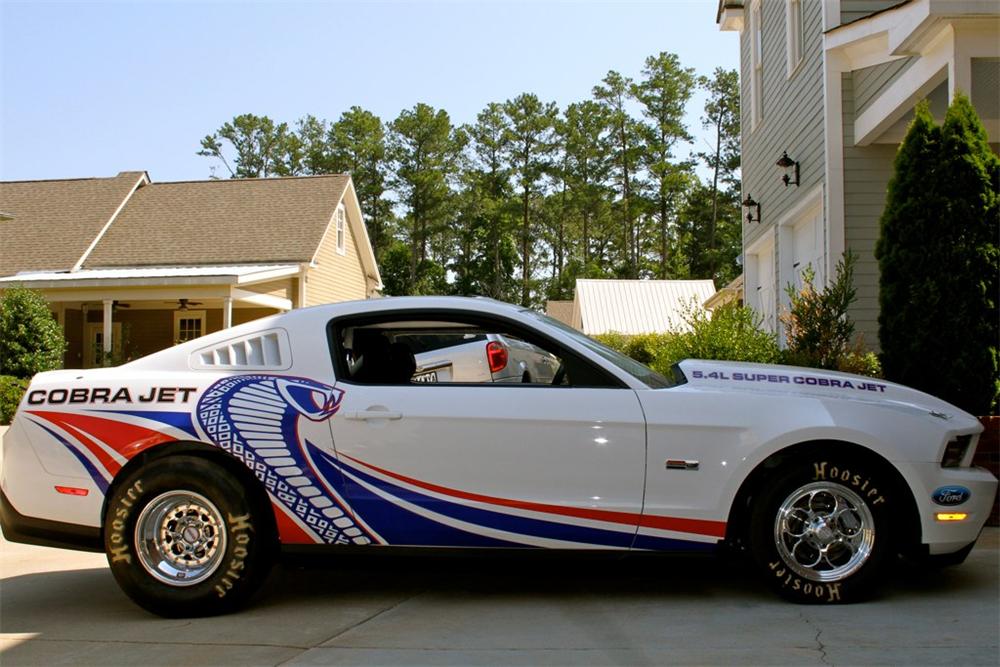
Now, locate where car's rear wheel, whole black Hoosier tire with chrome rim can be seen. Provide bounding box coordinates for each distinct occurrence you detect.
[104,455,276,617]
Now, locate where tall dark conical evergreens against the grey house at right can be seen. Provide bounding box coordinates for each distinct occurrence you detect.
[875,95,1000,414]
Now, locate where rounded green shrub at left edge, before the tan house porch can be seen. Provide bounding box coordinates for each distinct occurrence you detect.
[0,287,66,378]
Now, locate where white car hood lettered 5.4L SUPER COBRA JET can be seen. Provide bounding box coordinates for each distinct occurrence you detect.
[678,359,975,420]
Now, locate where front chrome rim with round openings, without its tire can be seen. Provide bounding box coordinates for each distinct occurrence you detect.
[774,482,875,581]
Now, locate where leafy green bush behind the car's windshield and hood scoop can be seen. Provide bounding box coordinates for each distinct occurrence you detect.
[595,303,781,375]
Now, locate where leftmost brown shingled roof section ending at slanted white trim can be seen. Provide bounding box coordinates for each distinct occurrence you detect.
[0,171,148,275]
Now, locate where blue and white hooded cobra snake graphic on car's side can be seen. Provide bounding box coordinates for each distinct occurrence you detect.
[197,375,371,544]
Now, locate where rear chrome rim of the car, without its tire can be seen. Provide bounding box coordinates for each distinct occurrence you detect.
[135,491,226,586]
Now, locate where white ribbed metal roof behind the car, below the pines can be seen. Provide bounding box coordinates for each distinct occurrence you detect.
[571,279,715,335]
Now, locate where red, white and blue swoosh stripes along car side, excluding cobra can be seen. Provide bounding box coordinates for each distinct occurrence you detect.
[28,402,726,551]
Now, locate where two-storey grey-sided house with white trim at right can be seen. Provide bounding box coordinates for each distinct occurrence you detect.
[716,0,1000,347]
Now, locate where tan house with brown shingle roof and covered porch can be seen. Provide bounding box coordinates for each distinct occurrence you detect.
[0,172,382,368]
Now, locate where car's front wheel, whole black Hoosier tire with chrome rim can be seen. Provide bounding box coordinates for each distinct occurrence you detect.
[750,455,895,604]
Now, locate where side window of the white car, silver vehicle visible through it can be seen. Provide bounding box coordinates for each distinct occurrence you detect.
[331,320,617,386]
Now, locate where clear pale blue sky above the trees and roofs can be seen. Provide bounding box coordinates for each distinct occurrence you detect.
[0,0,739,181]
